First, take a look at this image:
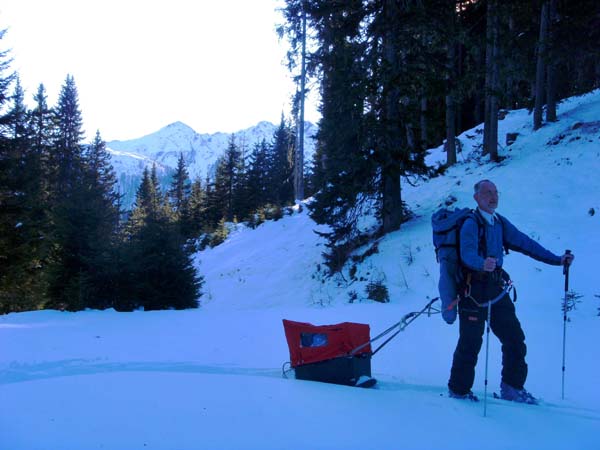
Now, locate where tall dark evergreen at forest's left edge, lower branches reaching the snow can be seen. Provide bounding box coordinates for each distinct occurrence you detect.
[307,1,374,272]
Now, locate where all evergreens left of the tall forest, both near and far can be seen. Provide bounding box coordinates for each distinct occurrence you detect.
[0,25,295,314]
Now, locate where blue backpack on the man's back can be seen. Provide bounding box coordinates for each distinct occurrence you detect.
[431,208,485,324]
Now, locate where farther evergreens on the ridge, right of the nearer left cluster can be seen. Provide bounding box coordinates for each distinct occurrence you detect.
[184,117,296,243]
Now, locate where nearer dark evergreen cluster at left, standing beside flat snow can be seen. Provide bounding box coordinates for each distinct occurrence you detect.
[0,61,202,313]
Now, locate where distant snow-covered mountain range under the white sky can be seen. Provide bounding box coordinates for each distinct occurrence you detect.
[106,122,317,208]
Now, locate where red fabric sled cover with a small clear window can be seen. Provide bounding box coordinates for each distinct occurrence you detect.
[283,319,371,367]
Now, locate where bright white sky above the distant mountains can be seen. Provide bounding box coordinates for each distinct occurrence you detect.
[0,0,319,141]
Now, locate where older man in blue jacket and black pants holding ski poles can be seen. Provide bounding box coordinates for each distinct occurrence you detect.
[448,180,574,404]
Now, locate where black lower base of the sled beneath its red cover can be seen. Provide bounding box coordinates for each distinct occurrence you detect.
[295,353,377,387]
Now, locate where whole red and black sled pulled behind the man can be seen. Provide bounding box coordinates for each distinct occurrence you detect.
[283,319,376,387]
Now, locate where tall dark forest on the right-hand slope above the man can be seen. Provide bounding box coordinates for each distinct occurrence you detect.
[280,0,600,272]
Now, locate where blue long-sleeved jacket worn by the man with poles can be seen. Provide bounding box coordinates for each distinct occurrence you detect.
[460,210,561,271]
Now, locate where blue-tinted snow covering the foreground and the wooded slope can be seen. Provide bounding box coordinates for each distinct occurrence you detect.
[0,91,600,450]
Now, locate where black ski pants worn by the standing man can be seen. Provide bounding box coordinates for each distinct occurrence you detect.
[448,283,527,394]
